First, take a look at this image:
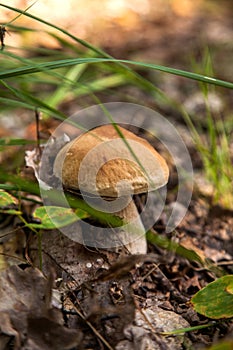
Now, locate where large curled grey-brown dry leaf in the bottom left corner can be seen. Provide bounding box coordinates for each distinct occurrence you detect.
[0,266,81,350]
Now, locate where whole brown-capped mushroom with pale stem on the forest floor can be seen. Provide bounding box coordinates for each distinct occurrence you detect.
[53,124,169,254]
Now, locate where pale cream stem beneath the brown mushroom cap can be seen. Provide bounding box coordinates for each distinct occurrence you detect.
[114,199,147,254]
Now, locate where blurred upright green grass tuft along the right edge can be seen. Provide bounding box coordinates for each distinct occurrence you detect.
[189,48,233,209]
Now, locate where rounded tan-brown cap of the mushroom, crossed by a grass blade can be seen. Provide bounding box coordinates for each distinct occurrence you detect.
[54,124,169,198]
